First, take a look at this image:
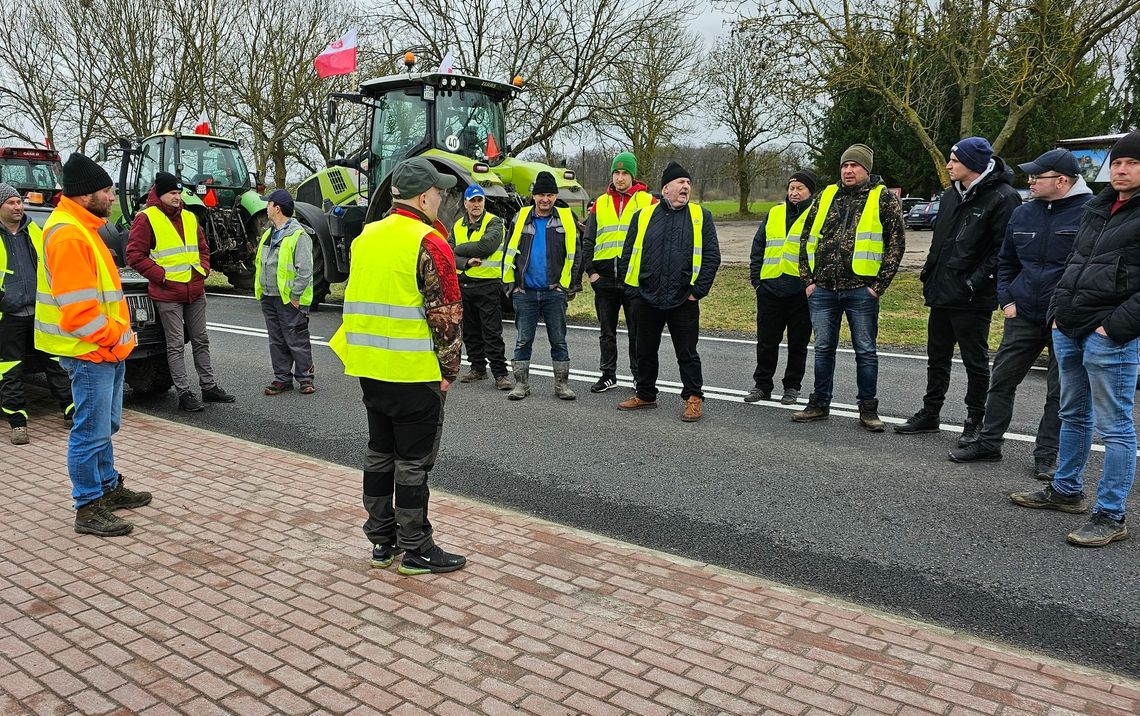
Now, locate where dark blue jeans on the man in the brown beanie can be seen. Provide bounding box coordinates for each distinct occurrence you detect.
[807,286,879,406]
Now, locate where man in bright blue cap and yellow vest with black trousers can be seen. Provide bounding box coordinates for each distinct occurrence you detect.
[447,184,511,390]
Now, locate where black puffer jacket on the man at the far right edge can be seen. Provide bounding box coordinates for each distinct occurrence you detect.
[1049,187,1140,343]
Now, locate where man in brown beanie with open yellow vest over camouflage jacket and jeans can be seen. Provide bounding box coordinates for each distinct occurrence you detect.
[792,144,906,432]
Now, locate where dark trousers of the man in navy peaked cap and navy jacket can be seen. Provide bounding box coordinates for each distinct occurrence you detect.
[978,318,1061,462]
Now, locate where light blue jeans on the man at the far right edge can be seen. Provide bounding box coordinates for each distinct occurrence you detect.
[1053,328,1140,520]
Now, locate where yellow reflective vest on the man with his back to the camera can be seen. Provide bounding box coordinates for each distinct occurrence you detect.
[328,214,442,383]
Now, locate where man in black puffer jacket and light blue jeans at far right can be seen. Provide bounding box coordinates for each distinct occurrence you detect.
[1010,131,1140,547]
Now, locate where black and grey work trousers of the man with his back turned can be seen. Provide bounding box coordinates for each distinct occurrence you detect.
[360,377,445,552]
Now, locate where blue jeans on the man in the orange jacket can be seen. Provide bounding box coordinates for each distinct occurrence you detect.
[59,358,127,510]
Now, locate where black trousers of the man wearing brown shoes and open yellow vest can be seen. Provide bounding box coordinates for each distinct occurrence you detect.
[634,299,705,400]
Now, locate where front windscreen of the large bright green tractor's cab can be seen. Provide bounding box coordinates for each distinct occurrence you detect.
[435,91,506,164]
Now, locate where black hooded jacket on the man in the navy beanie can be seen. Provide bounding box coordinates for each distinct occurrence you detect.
[919,156,1021,311]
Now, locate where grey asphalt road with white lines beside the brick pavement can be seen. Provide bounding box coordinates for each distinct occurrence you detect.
[120,295,1140,676]
